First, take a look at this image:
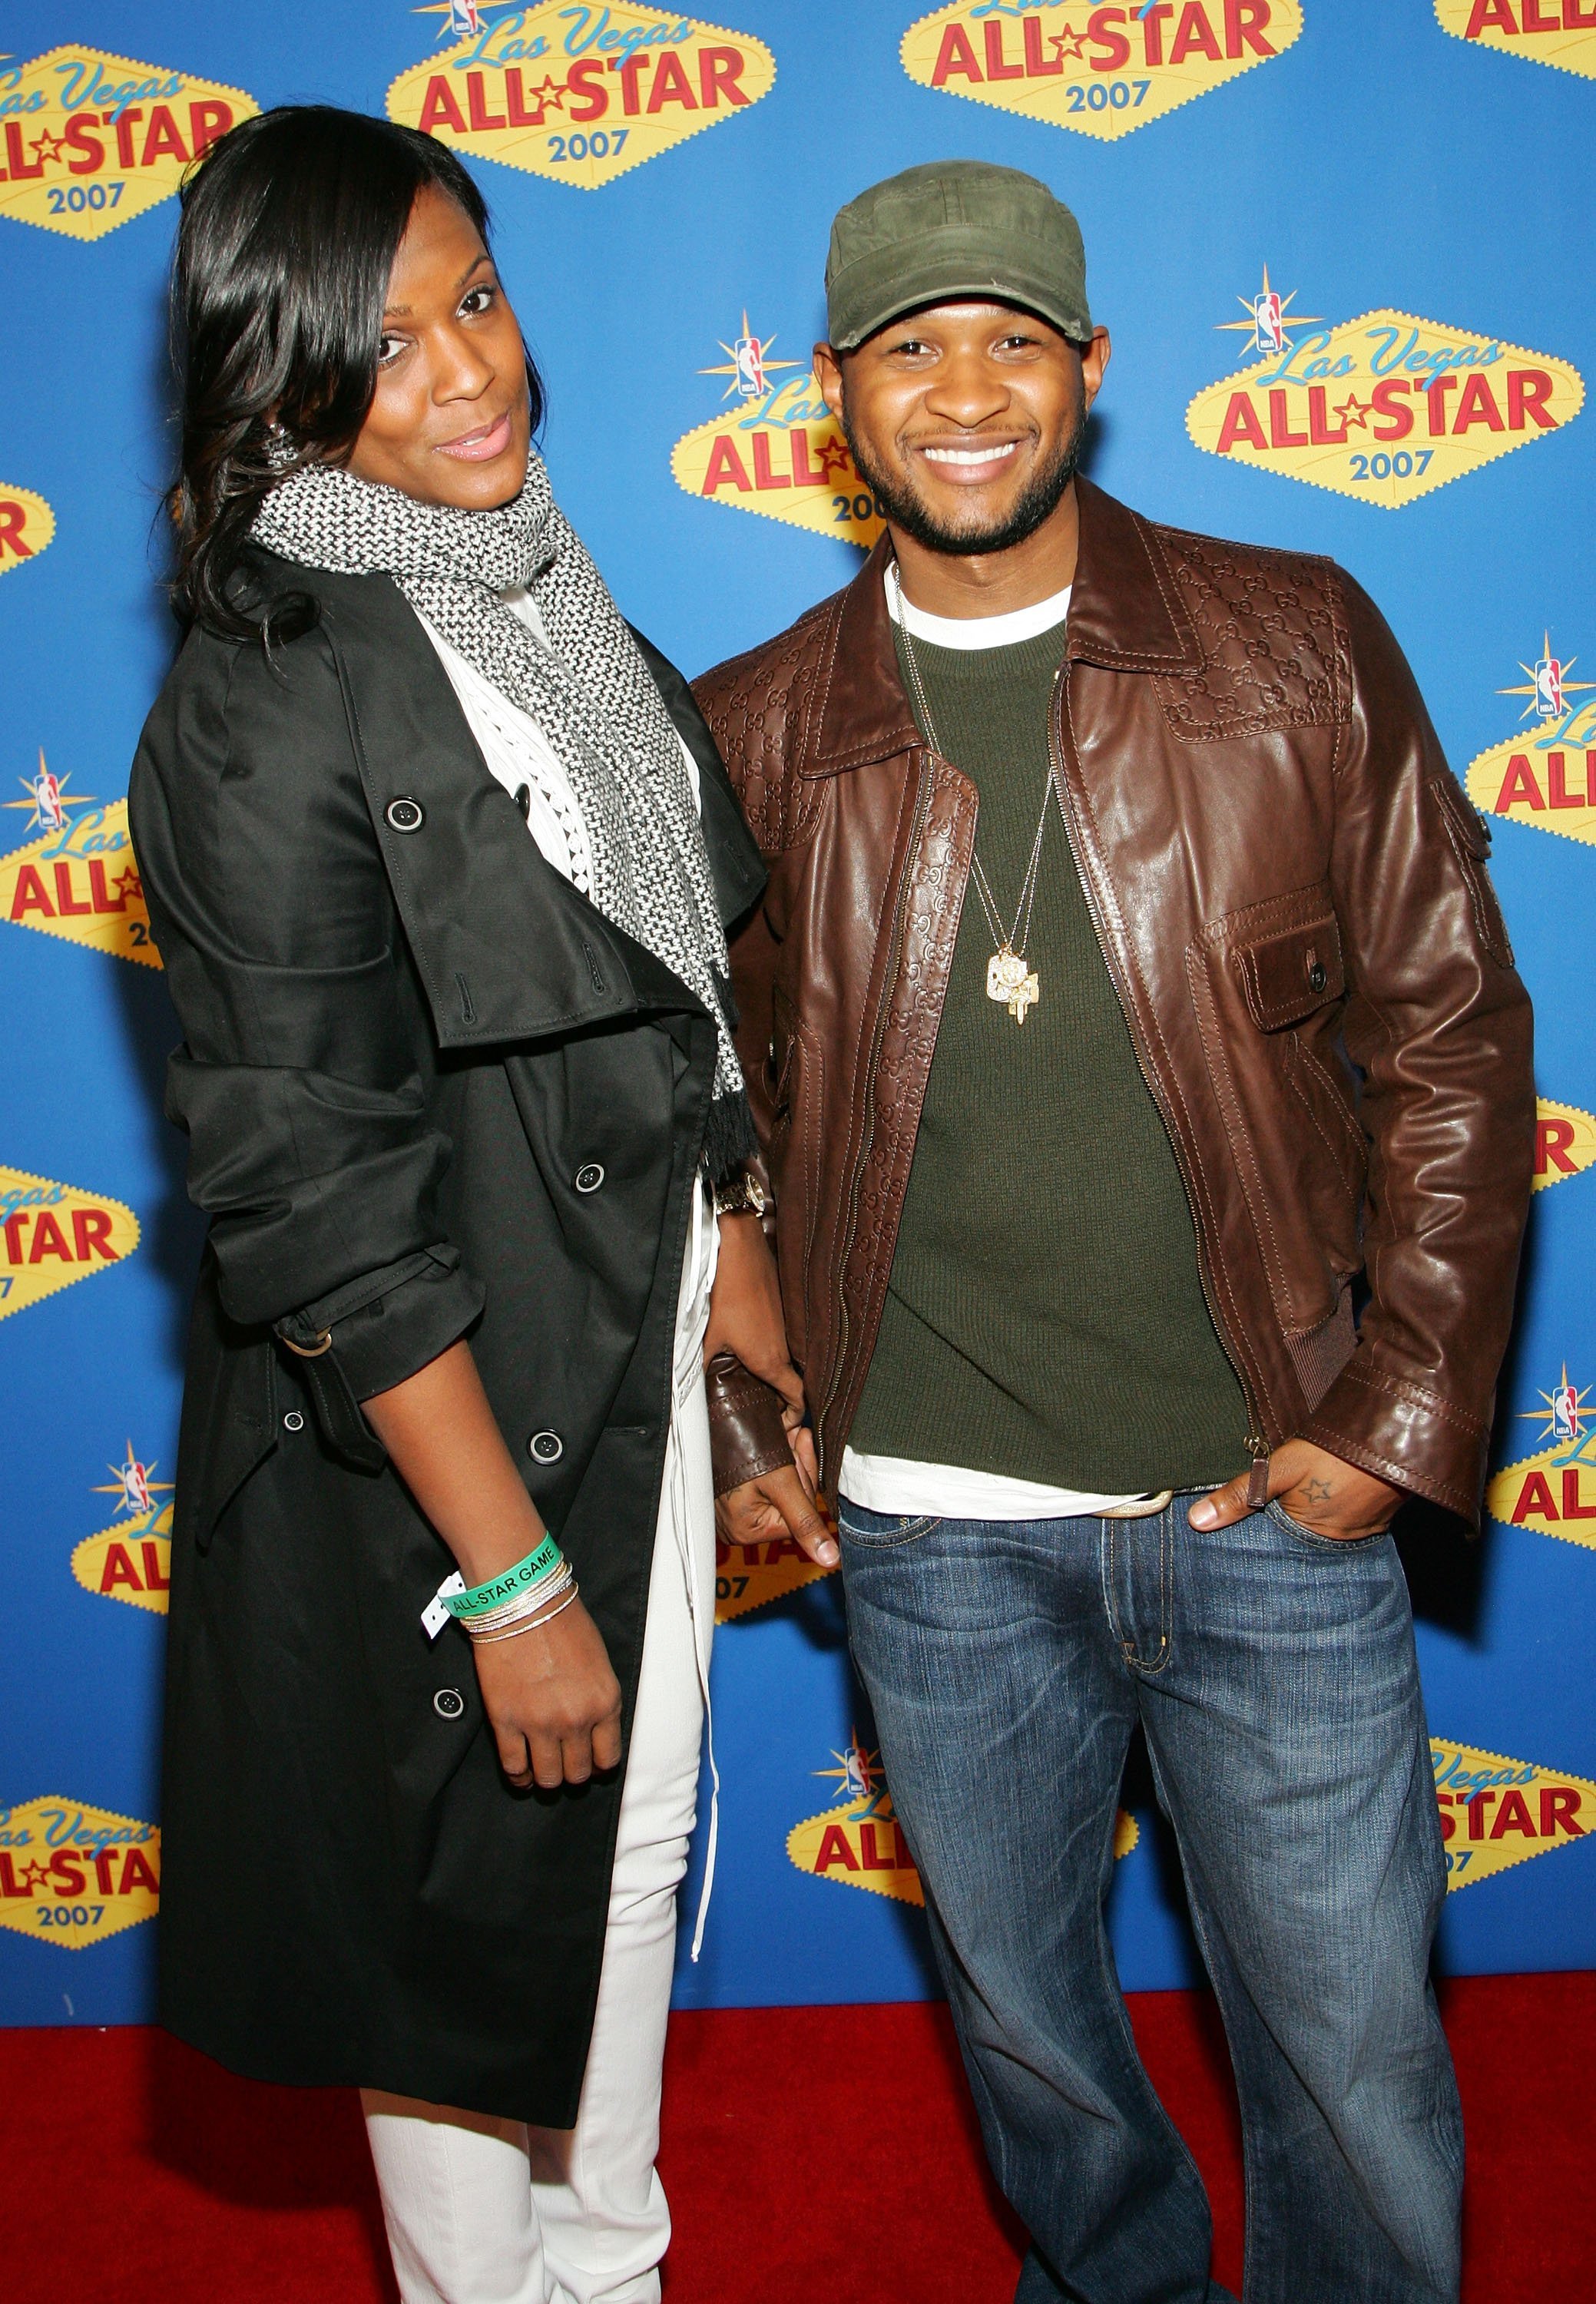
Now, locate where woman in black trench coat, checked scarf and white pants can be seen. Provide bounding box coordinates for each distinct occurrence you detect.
[131,108,829,2304]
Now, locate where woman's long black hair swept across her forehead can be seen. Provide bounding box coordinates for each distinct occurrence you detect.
[173,104,544,638]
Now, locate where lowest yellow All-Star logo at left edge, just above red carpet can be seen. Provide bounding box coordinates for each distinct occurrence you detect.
[0,1793,161,1951]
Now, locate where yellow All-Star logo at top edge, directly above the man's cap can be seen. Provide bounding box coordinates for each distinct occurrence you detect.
[898,0,1301,138]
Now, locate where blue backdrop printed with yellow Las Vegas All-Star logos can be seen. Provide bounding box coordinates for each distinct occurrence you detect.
[0,0,1596,2023]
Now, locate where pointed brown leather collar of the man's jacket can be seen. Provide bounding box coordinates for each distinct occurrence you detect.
[799,479,1202,776]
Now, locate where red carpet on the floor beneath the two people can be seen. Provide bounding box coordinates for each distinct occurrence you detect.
[0,1975,1596,2304]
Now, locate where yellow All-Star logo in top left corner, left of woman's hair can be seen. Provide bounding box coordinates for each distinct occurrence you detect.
[0,46,260,240]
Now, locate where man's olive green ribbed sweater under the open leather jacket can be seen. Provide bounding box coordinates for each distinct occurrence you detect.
[849,624,1248,1493]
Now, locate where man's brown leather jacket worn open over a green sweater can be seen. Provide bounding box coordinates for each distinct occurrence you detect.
[696,482,1534,1521]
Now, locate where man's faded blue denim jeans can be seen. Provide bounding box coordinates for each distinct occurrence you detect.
[840,1495,1462,2304]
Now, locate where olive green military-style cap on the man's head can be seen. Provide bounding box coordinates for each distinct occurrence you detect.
[826,159,1091,353]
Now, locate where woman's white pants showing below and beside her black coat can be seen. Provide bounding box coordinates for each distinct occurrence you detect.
[362,1219,717,2304]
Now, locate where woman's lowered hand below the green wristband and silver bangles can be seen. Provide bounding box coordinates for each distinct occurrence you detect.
[472,1599,620,1793]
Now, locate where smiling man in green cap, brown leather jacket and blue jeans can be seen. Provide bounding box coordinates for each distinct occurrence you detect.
[698,164,1534,2304]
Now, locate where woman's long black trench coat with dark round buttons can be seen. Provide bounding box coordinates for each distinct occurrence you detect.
[129,558,765,2127]
